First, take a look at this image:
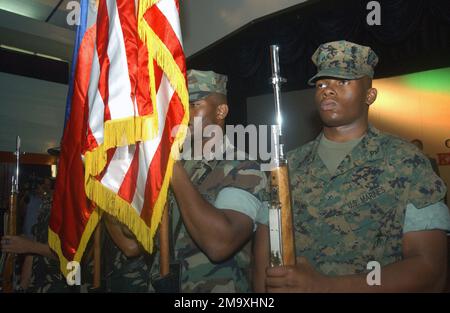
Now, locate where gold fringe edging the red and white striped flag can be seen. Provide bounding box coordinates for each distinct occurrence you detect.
[49,0,189,276]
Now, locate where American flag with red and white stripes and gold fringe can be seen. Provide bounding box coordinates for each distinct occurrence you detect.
[49,0,189,273]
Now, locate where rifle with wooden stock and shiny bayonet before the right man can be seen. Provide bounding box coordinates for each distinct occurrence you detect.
[269,45,295,266]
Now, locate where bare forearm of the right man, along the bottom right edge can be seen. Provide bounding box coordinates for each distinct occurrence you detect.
[325,256,446,292]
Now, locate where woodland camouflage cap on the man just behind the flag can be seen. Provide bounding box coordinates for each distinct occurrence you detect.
[187,70,228,102]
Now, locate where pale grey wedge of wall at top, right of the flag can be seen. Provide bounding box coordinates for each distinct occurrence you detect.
[180,0,307,57]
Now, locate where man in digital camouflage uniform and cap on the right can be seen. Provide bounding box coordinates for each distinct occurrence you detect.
[267,41,450,292]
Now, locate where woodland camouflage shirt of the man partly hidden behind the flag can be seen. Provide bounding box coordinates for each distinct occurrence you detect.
[152,150,267,293]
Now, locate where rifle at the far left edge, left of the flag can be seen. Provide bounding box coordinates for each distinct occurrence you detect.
[2,136,20,293]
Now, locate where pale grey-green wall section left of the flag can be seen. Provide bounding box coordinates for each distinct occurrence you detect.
[0,72,68,154]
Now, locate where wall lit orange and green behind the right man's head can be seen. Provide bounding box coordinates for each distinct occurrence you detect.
[369,68,450,203]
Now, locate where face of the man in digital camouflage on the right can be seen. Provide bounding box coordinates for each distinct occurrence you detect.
[315,78,369,127]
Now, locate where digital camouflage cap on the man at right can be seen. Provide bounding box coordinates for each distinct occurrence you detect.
[308,40,378,86]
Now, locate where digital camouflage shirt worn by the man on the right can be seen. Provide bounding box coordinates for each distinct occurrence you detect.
[288,126,446,275]
